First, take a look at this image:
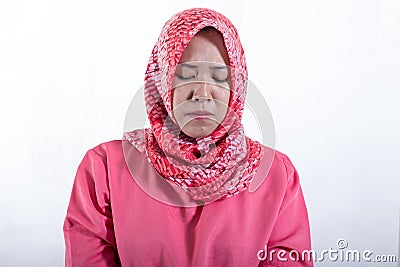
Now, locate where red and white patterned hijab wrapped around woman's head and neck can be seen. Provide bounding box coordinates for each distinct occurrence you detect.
[123,8,263,202]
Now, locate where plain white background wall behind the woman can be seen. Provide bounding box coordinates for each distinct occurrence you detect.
[0,0,400,266]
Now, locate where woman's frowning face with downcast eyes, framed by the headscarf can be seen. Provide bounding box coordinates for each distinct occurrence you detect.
[172,30,231,138]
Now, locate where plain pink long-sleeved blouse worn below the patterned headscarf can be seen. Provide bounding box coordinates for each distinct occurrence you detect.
[63,140,313,267]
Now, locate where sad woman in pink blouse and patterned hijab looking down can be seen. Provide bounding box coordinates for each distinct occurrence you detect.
[63,8,313,266]
